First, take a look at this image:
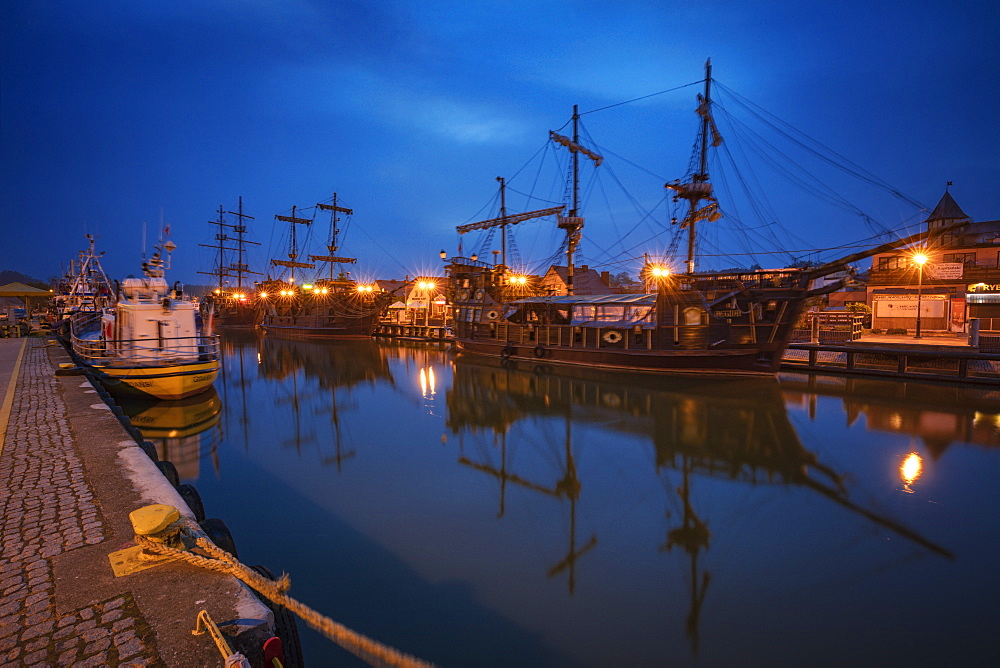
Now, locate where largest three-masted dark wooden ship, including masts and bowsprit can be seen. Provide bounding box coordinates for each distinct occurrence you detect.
[446,63,924,374]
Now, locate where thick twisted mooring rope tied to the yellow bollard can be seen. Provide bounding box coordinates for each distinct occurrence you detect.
[135,517,433,668]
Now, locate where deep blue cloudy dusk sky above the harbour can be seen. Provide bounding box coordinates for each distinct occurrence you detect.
[0,0,1000,284]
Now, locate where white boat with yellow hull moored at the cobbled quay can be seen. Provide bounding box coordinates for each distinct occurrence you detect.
[70,241,220,399]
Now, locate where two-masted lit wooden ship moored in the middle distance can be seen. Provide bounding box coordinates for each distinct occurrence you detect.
[258,194,392,339]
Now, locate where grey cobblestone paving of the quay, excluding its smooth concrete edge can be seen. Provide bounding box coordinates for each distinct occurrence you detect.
[0,339,164,667]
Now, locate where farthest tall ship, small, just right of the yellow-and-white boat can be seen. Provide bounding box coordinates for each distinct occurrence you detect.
[198,197,261,330]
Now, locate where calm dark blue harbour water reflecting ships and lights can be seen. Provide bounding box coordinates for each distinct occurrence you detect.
[128,332,1000,666]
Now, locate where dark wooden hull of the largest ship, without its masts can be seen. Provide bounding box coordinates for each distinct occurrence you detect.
[453,265,818,375]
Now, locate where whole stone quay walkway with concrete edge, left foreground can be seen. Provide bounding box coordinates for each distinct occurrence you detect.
[0,337,273,667]
